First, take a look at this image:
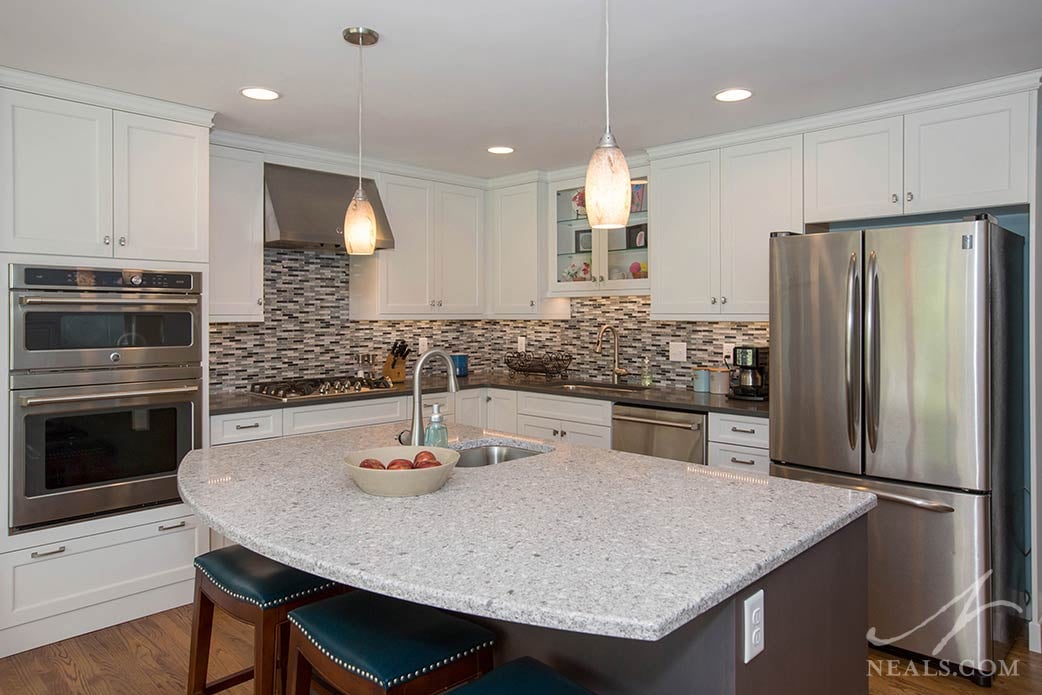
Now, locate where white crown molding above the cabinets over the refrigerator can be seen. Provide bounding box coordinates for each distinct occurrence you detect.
[647,70,1042,159]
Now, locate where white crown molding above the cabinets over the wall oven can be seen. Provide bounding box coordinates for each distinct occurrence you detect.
[0,66,214,128]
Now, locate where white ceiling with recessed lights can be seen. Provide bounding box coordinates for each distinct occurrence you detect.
[0,0,1042,176]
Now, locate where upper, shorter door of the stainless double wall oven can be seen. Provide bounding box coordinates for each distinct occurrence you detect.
[10,290,202,370]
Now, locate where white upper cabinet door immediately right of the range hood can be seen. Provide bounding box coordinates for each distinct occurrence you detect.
[377,174,435,314]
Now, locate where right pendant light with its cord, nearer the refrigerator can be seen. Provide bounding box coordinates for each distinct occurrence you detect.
[586,0,631,229]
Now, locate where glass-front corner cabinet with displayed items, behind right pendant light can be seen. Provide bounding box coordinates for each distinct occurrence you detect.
[549,168,651,297]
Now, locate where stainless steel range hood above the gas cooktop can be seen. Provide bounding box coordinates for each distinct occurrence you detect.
[264,164,394,251]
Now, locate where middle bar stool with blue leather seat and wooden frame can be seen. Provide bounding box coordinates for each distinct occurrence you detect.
[288,591,495,695]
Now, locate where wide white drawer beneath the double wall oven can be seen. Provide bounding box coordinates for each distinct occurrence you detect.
[0,516,208,629]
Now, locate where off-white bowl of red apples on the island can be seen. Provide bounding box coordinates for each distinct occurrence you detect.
[347,446,460,497]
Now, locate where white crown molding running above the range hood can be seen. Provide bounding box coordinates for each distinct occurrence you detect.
[209,130,488,189]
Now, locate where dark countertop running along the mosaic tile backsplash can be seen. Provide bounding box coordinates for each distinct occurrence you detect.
[209,372,768,418]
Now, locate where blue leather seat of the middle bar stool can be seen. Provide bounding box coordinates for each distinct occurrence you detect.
[290,591,495,690]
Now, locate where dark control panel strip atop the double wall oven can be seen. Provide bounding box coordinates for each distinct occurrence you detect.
[11,266,199,292]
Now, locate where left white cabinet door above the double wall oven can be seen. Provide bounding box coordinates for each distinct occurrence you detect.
[0,90,113,256]
